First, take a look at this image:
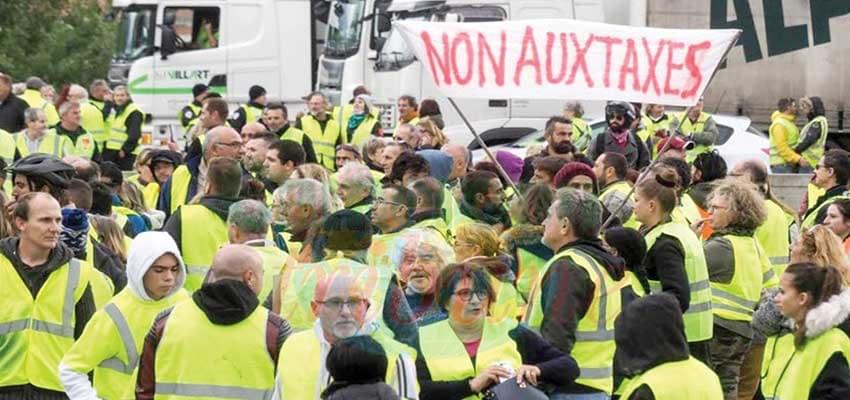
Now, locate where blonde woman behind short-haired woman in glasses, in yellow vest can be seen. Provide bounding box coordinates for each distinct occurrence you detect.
[454,222,525,319]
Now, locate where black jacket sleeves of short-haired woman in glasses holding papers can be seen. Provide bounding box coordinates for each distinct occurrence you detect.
[416,325,579,400]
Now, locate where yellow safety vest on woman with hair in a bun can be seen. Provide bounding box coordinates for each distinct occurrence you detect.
[645,222,714,342]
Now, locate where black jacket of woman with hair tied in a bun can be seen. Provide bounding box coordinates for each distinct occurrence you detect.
[641,220,691,313]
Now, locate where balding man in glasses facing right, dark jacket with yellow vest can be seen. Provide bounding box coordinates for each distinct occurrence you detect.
[156,126,244,216]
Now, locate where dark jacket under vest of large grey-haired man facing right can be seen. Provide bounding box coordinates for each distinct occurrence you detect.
[539,240,625,393]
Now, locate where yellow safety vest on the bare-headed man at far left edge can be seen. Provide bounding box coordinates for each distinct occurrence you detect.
[0,256,92,392]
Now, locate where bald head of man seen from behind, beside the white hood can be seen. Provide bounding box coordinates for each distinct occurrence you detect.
[207,244,263,294]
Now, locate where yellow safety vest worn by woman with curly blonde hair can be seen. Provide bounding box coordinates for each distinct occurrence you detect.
[711,235,778,322]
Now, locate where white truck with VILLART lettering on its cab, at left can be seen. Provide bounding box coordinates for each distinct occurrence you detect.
[107,0,325,139]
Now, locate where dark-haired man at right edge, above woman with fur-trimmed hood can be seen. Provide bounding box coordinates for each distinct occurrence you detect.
[801,149,850,229]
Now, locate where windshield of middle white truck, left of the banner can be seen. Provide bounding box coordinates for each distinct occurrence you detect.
[325,0,366,58]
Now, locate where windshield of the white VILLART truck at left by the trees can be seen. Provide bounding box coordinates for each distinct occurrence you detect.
[114,8,156,61]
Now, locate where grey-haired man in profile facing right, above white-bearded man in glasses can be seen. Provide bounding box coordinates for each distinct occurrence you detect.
[272,179,332,262]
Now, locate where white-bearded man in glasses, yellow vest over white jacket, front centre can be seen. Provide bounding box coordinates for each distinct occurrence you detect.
[275,273,419,399]
